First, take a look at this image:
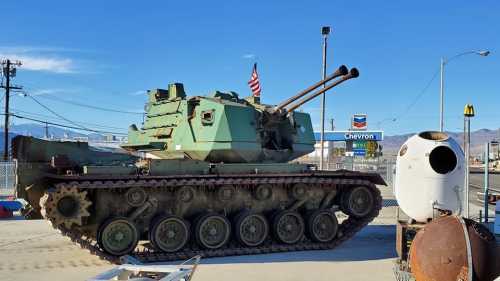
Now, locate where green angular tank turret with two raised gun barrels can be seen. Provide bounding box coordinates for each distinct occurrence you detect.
[123,66,359,163]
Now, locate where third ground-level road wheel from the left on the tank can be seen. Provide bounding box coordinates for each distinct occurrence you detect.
[195,213,231,249]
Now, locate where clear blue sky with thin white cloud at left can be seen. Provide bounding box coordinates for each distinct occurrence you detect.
[0,0,500,135]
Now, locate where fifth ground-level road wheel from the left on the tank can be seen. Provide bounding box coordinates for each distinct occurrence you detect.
[273,211,304,244]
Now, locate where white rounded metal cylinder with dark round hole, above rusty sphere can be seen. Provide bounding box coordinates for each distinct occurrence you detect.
[394,132,465,222]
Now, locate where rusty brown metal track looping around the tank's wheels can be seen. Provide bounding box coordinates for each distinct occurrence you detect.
[45,175,382,264]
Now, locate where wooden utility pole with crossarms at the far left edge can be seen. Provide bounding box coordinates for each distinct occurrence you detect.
[1,59,22,161]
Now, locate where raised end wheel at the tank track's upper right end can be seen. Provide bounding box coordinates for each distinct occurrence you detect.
[341,186,375,218]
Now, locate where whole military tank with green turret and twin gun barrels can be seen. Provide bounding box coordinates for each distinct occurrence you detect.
[13,66,385,262]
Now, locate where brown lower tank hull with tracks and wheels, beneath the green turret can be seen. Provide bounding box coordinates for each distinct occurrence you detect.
[13,138,385,263]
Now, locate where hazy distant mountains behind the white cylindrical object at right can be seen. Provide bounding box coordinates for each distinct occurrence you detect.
[381,129,500,156]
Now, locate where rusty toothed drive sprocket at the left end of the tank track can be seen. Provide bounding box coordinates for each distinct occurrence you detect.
[40,186,92,229]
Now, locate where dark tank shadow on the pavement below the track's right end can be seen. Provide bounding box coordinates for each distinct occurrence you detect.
[172,225,396,265]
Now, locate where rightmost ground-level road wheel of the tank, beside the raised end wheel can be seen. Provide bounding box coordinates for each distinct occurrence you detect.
[307,210,339,242]
